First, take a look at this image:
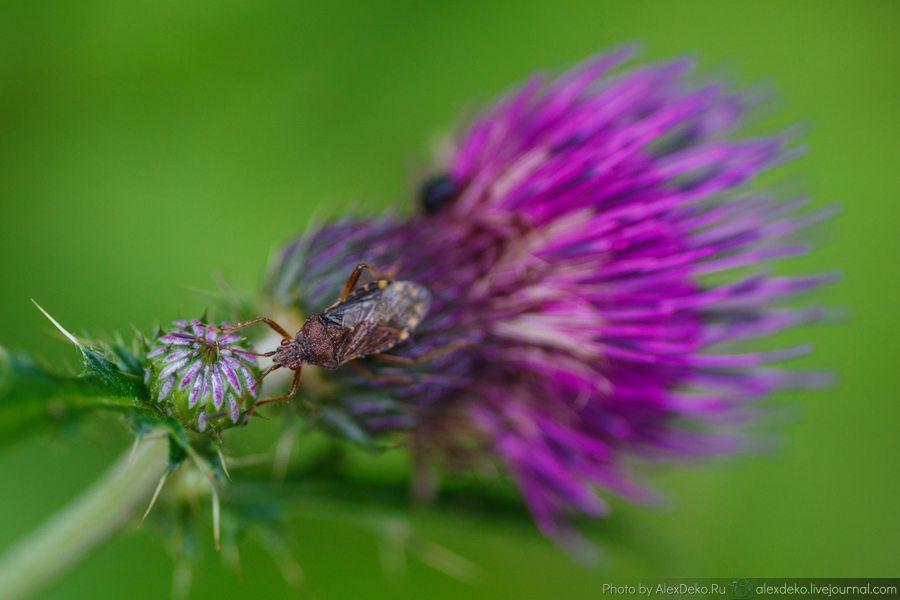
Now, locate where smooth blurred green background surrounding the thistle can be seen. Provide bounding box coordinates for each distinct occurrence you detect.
[0,0,900,600]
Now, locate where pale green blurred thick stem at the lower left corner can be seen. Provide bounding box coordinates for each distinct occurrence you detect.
[0,432,169,600]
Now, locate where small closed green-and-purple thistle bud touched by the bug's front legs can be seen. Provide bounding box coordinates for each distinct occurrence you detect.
[144,319,259,433]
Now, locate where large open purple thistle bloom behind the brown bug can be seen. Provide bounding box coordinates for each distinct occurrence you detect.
[269,49,834,539]
